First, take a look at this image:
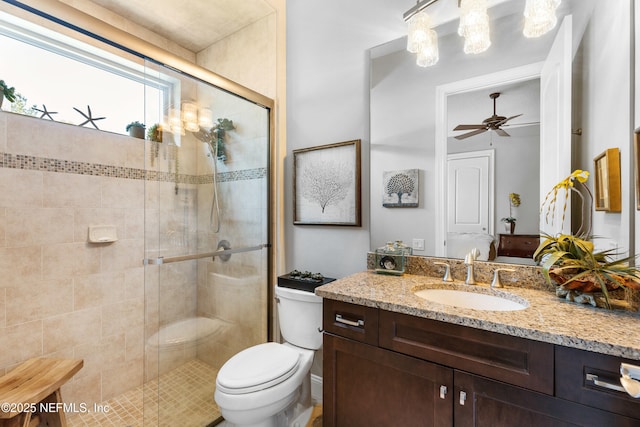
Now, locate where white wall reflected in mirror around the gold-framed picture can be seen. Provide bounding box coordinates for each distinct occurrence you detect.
[575,1,635,252]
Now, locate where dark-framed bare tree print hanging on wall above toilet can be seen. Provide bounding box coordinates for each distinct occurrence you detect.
[293,139,362,227]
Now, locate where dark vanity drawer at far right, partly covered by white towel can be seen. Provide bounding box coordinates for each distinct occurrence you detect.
[555,346,640,419]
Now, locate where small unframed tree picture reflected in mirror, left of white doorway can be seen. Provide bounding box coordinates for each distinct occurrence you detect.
[382,169,420,208]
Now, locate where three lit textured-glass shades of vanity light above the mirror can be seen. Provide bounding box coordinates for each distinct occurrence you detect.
[402,0,562,67]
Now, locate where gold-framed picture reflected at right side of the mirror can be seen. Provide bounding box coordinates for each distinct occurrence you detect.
[593,148,622,212]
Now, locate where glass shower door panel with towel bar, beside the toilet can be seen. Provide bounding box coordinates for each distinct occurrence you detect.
[144,63,270,426]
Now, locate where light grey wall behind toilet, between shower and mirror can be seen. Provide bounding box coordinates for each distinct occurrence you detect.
[284,0,404,277]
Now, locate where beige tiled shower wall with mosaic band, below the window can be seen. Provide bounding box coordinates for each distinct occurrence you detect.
[0,102,268,404]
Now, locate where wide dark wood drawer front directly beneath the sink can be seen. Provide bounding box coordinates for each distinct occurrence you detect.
[379,310,554,395]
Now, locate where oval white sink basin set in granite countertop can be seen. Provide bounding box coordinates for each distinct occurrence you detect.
[414,289,528,311]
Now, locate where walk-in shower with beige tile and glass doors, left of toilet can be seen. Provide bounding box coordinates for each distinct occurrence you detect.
[0,2,272,427]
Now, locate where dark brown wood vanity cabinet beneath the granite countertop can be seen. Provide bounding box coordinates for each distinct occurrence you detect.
[323,299,640,427]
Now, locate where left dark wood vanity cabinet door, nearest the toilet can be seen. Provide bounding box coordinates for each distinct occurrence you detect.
[322,333,453,427]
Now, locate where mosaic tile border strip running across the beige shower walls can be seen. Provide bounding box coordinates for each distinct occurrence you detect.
[0,153,267,184]
